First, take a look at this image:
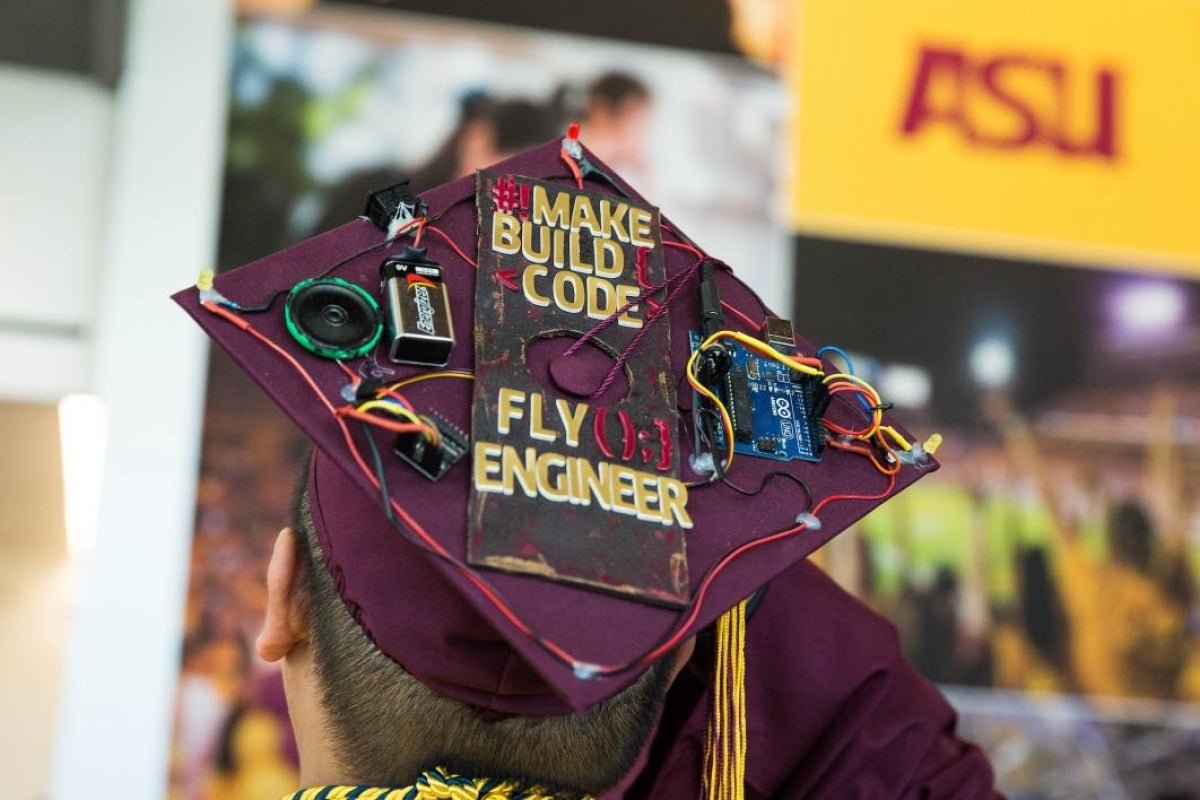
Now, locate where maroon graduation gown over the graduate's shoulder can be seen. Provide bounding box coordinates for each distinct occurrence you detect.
[624,561,998,800]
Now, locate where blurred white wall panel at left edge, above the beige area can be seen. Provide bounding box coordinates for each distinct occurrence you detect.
[0,65,114,401]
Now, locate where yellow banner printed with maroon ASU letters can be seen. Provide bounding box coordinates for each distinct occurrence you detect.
[788,0,1200,275]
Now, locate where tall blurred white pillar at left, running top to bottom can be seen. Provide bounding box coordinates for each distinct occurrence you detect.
[49,0,233,800]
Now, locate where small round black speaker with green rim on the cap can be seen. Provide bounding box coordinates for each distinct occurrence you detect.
[283,278,383,361]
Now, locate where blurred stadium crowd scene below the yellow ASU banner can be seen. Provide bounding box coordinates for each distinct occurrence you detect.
[796,237,1200,798]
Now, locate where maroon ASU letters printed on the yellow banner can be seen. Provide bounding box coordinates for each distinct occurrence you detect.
[900,46,1118,162]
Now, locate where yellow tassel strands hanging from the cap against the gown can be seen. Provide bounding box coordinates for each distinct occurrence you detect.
[704,601,748,800]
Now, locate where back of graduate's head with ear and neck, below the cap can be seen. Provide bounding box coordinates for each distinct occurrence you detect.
[258,470,686,793]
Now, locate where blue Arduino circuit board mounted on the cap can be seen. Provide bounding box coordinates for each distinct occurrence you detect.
[690,331,828,461]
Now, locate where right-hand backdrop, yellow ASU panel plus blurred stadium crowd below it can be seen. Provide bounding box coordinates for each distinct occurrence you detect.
[787,0,1200,798]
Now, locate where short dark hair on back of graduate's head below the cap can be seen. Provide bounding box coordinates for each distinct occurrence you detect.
[293,470,673,796]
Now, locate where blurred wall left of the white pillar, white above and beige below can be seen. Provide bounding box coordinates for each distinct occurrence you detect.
[0,59,114,798]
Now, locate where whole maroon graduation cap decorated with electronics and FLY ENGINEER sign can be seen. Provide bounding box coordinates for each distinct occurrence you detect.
[175,138,936,714]
